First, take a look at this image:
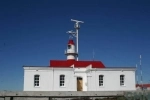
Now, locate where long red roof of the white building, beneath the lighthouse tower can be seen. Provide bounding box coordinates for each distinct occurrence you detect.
[50,60,105,68]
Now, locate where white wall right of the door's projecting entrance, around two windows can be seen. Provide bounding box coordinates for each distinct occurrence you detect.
[88,71,136,91]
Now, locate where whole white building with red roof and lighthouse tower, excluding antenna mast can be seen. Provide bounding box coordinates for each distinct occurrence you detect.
[24,40,136,91]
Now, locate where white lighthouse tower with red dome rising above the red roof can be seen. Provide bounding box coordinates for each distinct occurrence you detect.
[65,39,78,60]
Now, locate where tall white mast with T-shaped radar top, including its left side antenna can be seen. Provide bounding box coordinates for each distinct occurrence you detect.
[68,19,84,61]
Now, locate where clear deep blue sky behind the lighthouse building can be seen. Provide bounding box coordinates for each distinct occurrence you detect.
[0,0,150,91]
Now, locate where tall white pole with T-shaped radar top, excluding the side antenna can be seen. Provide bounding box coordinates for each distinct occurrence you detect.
[71,19,84,61]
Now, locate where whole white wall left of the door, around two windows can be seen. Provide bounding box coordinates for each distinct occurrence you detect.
[24,67,77,91]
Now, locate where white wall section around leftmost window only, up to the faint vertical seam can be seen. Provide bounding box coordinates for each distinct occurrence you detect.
[24,70,53,91]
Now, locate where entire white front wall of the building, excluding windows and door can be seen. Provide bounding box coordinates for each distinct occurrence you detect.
[24,67,136,91]
